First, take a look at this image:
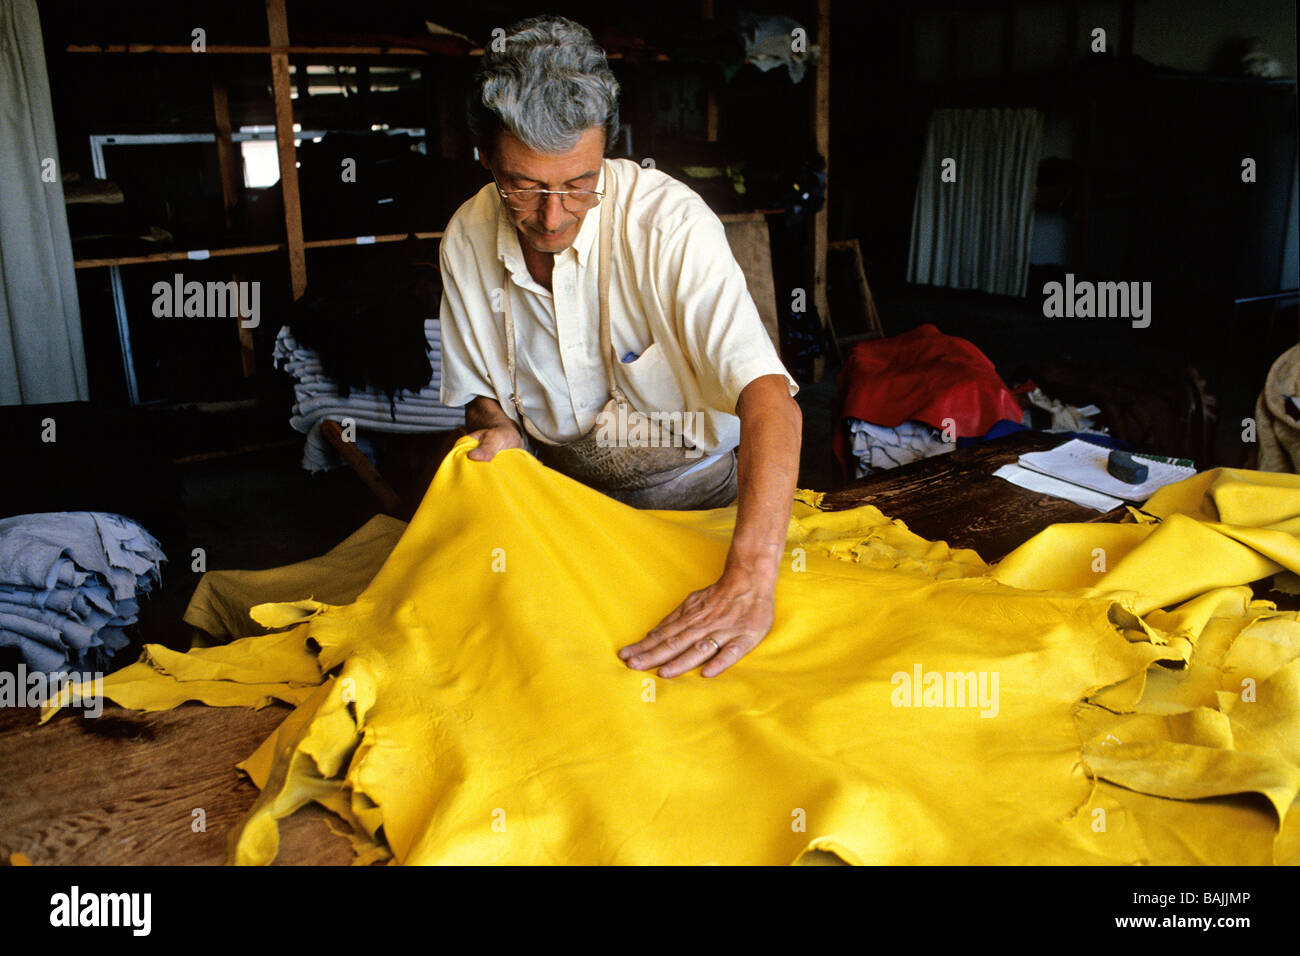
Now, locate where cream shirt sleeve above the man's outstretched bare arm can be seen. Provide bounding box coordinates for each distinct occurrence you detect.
[659,200,800,415]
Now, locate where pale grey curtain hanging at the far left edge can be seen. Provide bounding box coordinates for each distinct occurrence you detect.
[0,0,90,405]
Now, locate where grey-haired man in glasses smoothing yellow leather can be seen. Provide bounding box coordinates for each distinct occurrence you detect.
[441,17,801,678]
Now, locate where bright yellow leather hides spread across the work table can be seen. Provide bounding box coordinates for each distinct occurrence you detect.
[47,438,1300,864]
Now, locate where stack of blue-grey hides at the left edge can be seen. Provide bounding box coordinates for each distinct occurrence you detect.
[0,511,166,674]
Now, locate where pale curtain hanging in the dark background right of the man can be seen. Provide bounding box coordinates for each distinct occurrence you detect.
[907,109,1043,295]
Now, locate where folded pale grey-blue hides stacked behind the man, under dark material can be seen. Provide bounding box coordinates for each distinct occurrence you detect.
[274,319,465,472]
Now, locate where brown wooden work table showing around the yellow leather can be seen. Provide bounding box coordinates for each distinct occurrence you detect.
[0,433,1159,865]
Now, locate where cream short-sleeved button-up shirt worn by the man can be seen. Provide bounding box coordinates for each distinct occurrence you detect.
[439,159,798,455]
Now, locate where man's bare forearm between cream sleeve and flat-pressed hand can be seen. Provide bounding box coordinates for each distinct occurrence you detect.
[727,375,803,581]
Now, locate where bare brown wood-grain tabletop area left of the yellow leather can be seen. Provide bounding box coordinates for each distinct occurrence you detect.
[0,704,352,866]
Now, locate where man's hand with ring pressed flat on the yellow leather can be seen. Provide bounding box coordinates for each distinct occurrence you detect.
[619,570,776,678]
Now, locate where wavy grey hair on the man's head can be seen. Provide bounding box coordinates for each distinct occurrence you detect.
[467,17,619,155]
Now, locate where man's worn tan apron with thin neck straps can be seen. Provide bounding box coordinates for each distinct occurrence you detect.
[502,175,737,510]
